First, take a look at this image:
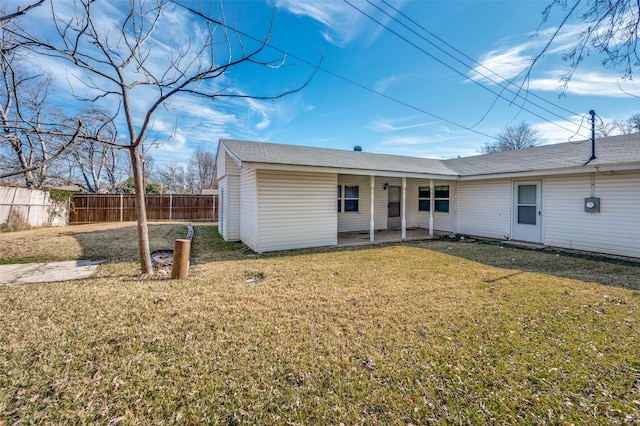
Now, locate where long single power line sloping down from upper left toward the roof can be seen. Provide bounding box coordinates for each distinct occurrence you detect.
[169,0,496,139]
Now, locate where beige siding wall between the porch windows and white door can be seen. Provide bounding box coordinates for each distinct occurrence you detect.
[456,179,512,239]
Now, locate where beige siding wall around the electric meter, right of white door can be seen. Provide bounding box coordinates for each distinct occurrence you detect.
[542,172,640,257]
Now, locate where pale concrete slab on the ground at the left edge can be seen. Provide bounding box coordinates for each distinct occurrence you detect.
[0,260,104,286]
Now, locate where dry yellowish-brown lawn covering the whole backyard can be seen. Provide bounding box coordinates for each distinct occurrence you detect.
[0,224,640,425]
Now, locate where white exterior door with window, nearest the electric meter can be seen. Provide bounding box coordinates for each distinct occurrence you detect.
[511,180,542,243]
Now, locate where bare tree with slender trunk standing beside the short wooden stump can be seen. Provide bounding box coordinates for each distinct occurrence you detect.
[10,0,320,274]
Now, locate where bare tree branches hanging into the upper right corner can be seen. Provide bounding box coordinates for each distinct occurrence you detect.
[531,0,640,87]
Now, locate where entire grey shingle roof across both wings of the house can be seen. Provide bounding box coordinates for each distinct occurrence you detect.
[220,133,640,176]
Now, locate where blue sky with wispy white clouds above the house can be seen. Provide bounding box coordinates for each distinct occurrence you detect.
[12,0,640,167]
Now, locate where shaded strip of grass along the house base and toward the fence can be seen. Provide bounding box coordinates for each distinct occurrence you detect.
[67,223,640,290]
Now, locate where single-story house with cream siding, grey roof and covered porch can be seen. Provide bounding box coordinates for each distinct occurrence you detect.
[215,134,640,258]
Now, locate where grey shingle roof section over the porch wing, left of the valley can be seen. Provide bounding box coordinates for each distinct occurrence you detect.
[220,139,457,176]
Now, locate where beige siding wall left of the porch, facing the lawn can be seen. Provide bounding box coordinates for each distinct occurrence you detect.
[256,170,338,253]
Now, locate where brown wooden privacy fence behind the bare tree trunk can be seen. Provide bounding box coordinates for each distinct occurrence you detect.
[69,194,218,223]
